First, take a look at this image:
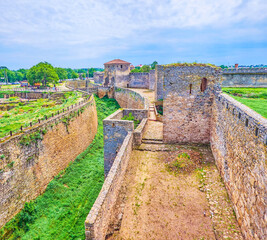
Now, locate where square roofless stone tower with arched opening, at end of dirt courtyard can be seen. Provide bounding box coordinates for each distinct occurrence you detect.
[162,66,221,143]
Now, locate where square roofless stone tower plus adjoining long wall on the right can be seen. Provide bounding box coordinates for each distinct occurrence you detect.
[156,65,267,239]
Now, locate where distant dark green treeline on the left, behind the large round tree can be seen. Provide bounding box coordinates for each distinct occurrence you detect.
[0,62,104,83]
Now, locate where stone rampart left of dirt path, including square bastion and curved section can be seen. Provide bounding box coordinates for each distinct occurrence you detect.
[85,88,149,240]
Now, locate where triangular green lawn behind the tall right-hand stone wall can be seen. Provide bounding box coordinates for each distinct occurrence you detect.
[222,88,267,118]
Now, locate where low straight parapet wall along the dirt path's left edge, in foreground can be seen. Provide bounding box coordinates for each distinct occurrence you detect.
[85,132,133,240]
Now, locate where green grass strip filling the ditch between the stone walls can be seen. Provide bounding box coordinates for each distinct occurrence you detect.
[0,94,119,240]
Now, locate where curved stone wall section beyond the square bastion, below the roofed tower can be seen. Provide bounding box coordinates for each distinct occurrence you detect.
[114,87,149,109]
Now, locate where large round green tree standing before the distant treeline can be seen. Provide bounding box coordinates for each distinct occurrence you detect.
[27,62,59,86]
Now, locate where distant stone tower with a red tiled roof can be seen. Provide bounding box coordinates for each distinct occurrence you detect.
[104,59,130,87]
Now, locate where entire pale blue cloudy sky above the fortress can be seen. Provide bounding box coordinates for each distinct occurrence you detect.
[0,0,267,69]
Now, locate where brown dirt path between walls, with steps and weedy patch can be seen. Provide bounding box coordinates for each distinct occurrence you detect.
[109,90,243,240]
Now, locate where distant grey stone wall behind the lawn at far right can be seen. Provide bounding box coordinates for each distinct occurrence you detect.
[222,68,267,87]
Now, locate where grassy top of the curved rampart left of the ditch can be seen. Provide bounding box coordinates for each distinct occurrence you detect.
[0,92,82,138]
